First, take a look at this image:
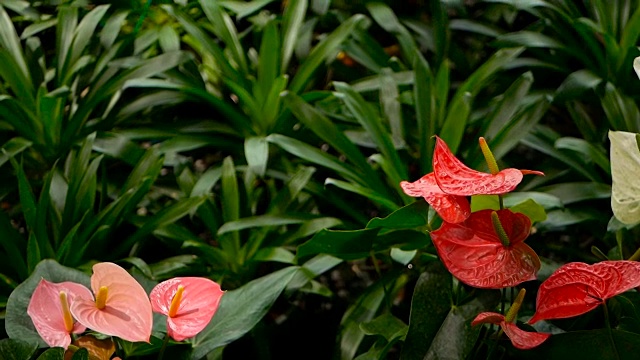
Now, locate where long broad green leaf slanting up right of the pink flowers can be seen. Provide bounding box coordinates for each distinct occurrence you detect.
[192,266,299,360]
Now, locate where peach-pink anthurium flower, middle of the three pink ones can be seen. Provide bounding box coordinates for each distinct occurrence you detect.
[71,262,153,342]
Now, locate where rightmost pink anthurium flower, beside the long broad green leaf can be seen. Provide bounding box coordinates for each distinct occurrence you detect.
[149,277,224,341]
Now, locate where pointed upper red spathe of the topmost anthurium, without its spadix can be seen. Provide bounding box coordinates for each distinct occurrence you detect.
[433,137,523,196]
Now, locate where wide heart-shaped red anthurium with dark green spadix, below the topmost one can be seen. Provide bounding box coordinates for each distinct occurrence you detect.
[431,209,540,289]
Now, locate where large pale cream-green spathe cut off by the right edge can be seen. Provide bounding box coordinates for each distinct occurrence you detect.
[609,131,640,224]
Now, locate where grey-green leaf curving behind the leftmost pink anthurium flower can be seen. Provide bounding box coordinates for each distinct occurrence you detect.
[5,259,90,347]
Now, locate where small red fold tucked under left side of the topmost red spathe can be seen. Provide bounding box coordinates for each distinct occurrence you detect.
[400,173,471,224]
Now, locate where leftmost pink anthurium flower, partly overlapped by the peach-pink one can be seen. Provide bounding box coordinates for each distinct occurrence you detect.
[27,279,91,349]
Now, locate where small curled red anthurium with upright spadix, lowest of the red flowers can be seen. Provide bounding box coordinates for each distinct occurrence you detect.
[471,289,551,350]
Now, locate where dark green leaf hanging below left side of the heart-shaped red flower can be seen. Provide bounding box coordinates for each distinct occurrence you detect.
[400,262,452,360]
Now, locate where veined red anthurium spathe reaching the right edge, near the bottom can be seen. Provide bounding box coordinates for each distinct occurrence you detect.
[529,260,640,324]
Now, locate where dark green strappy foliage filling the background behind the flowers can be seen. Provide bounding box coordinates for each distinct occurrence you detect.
[0,0,640,359]
